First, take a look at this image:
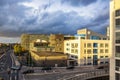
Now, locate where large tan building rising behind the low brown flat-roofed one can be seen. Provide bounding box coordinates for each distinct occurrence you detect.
[21,34,64,52]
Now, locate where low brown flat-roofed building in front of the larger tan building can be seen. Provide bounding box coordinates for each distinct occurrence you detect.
[30,39,68,67]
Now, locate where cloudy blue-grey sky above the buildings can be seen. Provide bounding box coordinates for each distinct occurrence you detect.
[0,0,109,42]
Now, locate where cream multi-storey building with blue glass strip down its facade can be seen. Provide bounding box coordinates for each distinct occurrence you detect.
[64,29,110,65]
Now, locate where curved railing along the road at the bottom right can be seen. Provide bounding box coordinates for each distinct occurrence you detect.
[63,69,109,80]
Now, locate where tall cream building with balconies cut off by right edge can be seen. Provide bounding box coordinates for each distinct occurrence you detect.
[110,0,120,80]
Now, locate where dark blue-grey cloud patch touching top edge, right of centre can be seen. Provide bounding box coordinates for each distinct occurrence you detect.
[61,0,97,7]
